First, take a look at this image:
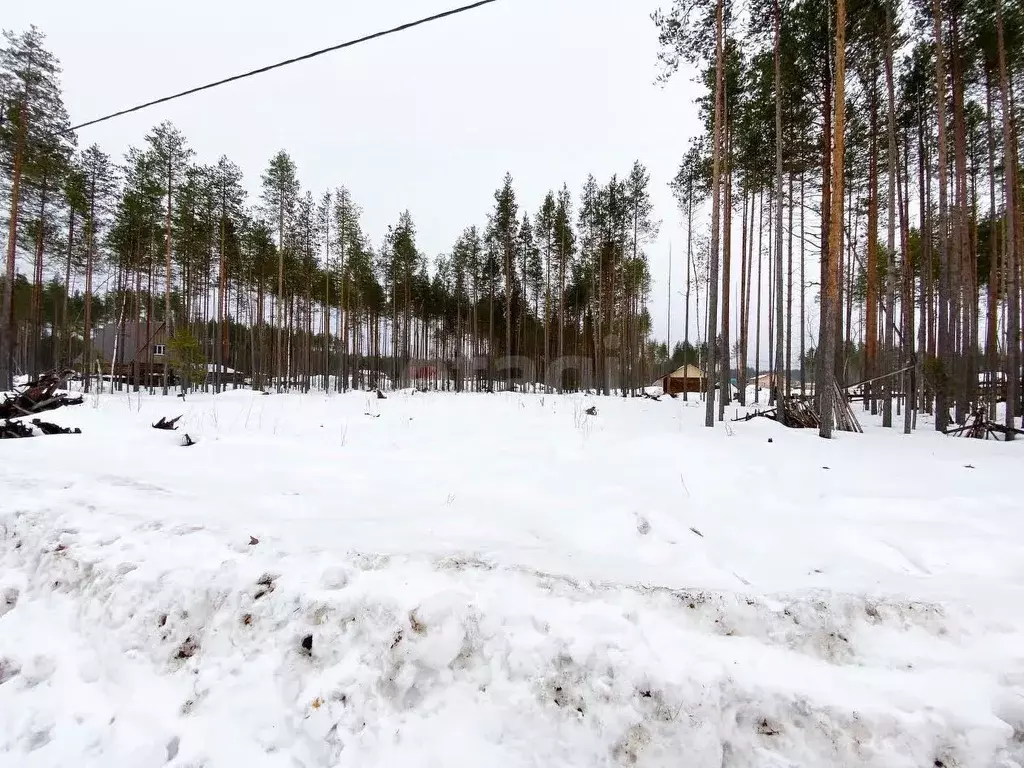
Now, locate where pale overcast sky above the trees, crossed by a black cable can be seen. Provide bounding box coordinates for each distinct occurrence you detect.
[8,0,712,348]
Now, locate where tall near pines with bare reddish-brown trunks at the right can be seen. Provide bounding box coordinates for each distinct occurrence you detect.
[653,0,1024,436]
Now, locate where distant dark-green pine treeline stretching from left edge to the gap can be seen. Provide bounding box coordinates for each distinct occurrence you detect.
[0,28,658,393]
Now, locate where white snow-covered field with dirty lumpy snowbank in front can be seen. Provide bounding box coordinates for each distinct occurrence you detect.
[0,390,1024,768]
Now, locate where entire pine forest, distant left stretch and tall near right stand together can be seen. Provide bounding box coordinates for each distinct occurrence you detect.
[0,0,1024,435]
